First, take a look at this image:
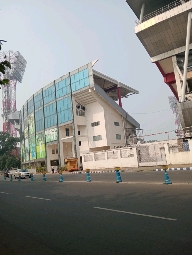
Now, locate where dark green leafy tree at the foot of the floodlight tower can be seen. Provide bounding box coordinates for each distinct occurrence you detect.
[0,131,21,169]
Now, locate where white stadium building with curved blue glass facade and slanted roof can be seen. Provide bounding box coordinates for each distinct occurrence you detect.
[18,61,140,171]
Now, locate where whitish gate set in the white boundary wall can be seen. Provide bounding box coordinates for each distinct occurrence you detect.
[137,143,167,166]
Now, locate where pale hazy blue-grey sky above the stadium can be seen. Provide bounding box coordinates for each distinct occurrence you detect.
[0,0,175,140]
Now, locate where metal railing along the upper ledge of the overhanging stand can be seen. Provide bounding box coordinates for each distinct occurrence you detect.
[135,0,191,25]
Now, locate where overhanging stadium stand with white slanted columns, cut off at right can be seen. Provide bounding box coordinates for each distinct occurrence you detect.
[126,0,192,137]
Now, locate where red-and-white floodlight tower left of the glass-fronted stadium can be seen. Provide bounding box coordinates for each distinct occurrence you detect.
[0,51,27,136]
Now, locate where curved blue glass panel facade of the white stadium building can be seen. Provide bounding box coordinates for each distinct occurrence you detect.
[20,64,93,163]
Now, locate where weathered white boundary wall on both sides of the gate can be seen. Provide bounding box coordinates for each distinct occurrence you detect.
[81,140,192,170]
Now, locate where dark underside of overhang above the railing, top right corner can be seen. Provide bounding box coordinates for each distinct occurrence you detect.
[126,0,175,19]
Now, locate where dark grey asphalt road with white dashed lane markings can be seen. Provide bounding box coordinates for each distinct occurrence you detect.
[0,171,192,255]
